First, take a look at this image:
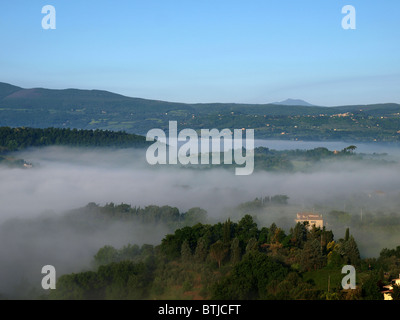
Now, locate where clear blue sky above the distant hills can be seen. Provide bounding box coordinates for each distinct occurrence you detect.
[0,0,400,106]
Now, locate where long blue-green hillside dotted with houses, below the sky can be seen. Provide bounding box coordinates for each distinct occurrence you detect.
[0,83,400,141]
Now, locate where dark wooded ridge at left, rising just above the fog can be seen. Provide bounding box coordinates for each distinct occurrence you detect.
[0,127,148,152]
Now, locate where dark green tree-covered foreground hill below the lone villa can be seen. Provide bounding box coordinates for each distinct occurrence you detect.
[47,215,390,299]
